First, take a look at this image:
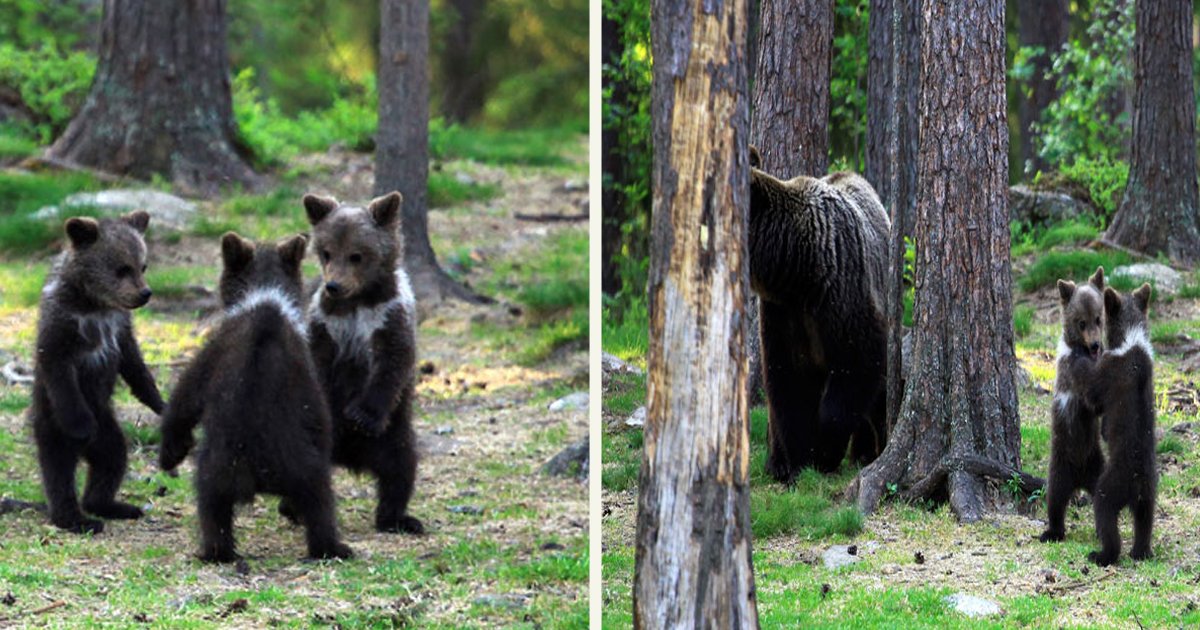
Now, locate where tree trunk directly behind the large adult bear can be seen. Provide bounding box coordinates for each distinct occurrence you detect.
[746,0,833,400]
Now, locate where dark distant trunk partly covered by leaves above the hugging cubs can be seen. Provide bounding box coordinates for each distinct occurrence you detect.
[1016,0,1070,173]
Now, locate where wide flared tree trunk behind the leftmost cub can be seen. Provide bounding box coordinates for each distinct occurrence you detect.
[47,0,258,194]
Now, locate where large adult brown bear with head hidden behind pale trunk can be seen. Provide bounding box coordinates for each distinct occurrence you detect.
[749,149,890,482]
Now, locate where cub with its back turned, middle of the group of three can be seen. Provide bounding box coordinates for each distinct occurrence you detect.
[160,233,354,562]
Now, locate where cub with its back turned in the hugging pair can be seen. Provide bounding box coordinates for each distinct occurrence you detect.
[1073,284,1158,566]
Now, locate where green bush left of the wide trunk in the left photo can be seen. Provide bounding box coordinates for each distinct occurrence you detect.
[0,43,96,144]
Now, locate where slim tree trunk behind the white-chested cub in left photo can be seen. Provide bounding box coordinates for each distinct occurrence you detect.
[374,0,485,302]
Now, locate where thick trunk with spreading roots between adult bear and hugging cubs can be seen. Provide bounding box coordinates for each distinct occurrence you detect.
[848,0,1020,521]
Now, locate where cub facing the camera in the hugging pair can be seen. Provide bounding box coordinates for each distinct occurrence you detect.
[1039,268,1104,542]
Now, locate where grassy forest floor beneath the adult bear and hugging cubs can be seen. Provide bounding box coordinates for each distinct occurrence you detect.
[602,234,1200,629]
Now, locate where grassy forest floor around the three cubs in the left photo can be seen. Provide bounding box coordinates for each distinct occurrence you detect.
[0,138,588,628]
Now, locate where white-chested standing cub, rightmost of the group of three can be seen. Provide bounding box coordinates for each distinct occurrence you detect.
[302,192,424,534]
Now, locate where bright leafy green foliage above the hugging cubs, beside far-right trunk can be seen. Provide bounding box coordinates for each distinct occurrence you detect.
[1012,0,1134,171]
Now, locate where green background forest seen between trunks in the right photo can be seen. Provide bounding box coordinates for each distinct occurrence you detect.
[602,0,1200,343]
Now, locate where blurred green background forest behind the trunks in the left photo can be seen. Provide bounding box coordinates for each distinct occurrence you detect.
[0,0,588,169]
